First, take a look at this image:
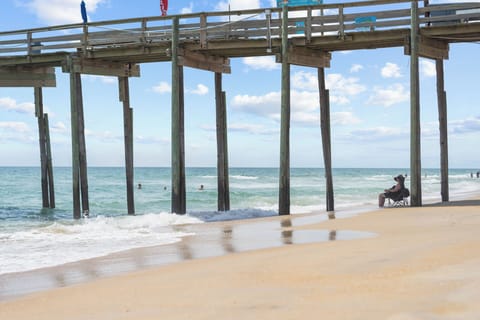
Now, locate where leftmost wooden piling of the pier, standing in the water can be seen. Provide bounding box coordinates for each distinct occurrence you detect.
[34,87,50,208]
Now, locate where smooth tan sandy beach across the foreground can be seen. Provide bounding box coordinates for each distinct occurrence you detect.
[0,200,480,320]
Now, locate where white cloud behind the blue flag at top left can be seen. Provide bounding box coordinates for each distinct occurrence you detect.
[22,0,107,25]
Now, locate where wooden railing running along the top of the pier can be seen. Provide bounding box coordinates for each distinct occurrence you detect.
[0,0,480,59]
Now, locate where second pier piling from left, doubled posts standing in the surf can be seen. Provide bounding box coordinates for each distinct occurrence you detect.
[70,69,90,219]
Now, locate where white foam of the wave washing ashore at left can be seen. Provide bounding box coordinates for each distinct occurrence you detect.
[0,213,202,274]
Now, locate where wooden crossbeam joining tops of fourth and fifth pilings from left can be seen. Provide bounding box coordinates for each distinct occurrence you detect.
[178,50,232,73]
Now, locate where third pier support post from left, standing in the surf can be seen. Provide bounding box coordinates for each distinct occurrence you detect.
[118,77,135,215]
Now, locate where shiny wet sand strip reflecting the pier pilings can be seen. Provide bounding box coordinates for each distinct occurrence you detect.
[0,214,374,300]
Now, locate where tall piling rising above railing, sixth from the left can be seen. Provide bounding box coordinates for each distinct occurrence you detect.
[278,6,290,215]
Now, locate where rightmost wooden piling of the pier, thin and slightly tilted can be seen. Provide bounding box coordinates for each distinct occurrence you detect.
[436,59,449,202]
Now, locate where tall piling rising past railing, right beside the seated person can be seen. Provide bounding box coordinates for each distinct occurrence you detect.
[410,1,422,207]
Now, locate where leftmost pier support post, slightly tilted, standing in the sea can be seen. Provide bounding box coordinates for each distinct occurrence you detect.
[34,87,55,208]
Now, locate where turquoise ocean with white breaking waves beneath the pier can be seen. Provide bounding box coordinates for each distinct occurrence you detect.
[0,167,480,275]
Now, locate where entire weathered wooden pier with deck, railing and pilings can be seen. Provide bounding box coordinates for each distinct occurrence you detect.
[0,0,480,218]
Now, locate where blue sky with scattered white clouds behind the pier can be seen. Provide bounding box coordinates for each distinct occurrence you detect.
[0,0,480,169]
